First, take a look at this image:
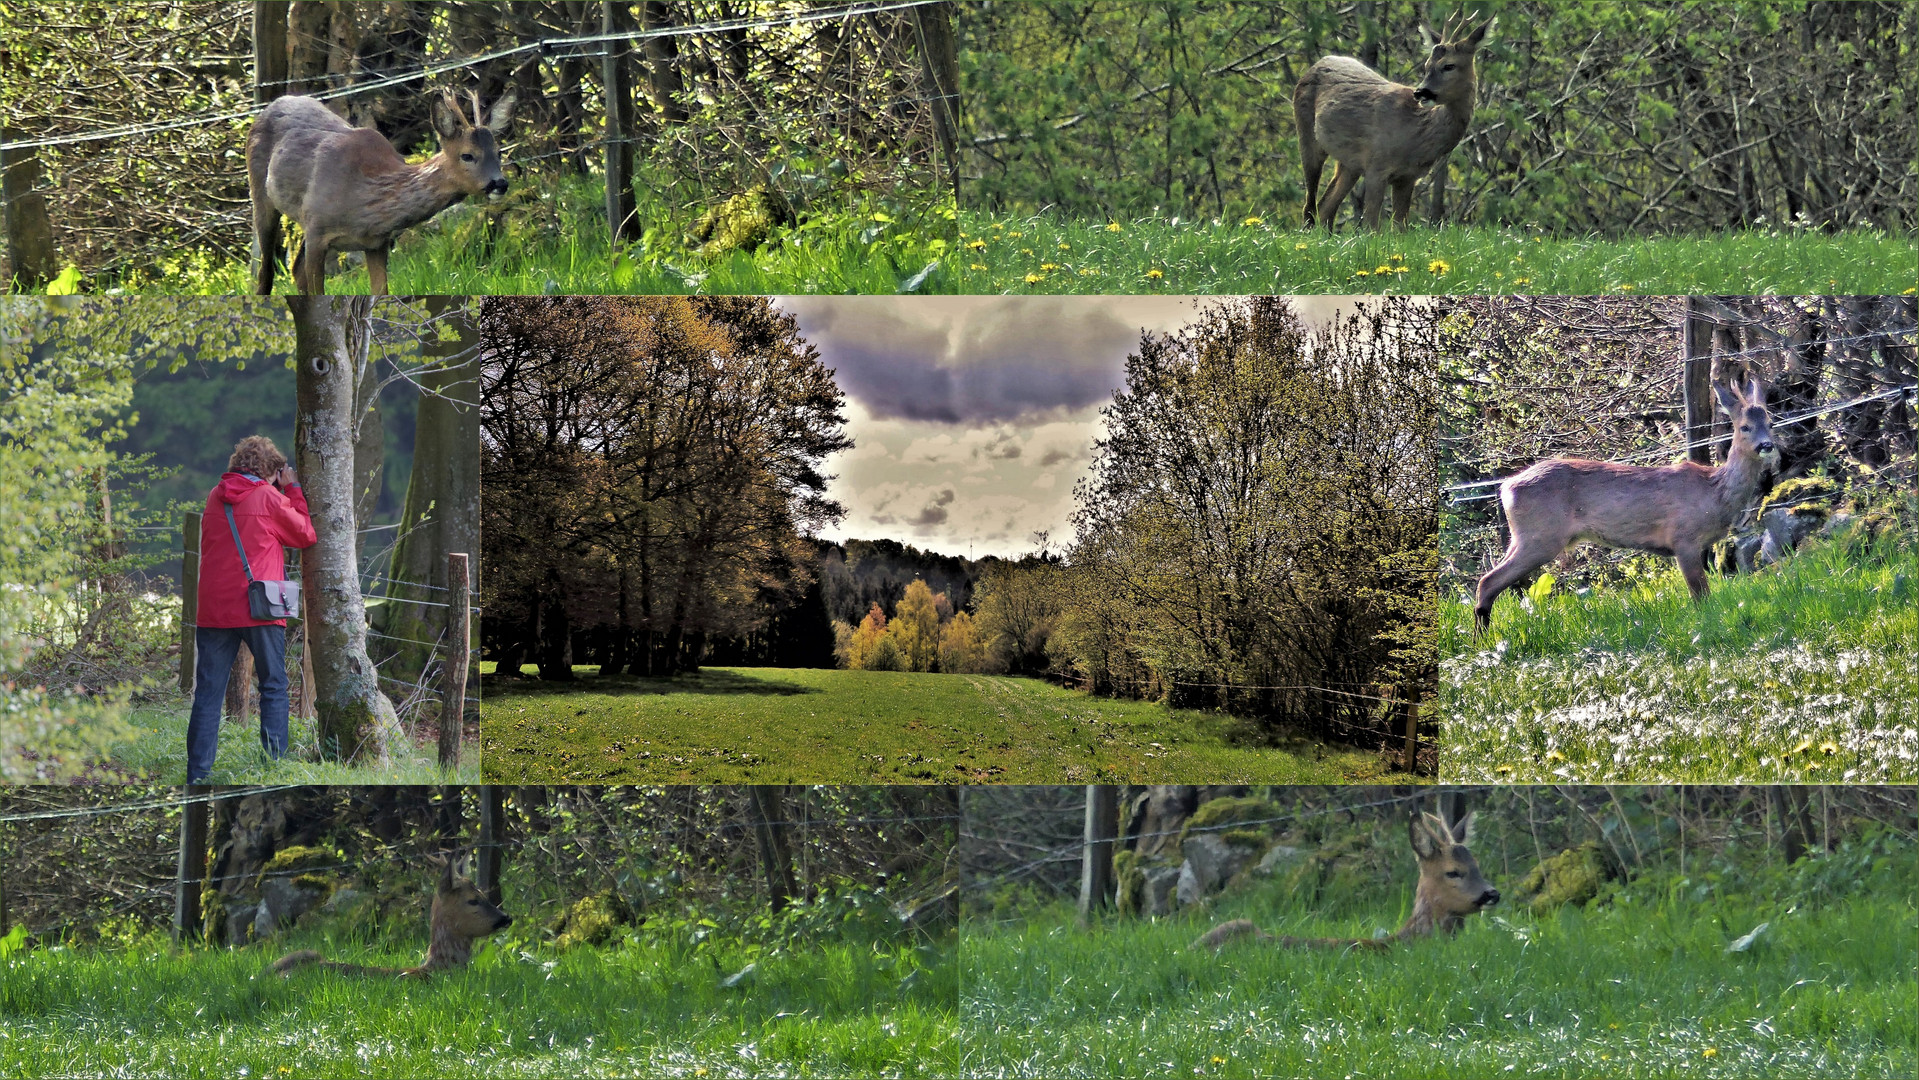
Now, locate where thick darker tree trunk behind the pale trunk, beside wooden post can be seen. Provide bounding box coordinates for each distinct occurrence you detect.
[382,295,480,681]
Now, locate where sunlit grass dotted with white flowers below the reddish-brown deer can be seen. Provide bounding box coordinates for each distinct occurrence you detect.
[1439,537,1919,785]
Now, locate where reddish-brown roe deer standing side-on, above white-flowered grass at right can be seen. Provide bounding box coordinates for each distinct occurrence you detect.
[1474,380,1773,633]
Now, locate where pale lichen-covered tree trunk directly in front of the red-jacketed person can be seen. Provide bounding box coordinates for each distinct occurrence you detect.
[286,295,399,765]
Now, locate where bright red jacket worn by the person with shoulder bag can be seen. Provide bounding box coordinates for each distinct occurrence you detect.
[194,472,315,627]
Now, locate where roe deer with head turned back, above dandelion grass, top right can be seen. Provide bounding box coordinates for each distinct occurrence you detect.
[1293,17,1495,230]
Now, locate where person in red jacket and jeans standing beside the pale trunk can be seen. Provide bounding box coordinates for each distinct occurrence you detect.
[186,435,313,785]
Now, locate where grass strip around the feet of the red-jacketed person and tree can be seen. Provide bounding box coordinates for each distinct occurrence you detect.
[96,693,480,785]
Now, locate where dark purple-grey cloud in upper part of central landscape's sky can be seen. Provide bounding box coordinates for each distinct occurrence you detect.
[781,297,1140,426]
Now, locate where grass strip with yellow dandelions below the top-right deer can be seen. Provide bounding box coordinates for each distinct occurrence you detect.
[958,207,1919,295]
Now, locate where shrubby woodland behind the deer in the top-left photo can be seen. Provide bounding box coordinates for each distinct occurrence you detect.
[0,0,954,284]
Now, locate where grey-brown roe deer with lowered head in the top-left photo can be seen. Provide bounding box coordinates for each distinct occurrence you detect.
[246,90,512,295]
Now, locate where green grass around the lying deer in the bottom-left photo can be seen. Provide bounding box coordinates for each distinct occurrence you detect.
[0,904,958,1080]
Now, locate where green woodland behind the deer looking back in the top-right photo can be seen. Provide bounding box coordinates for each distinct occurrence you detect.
[958,0,1919,236]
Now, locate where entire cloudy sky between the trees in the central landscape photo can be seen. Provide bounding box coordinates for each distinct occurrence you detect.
[779,295,1349,558]
